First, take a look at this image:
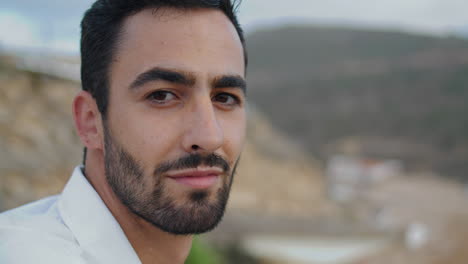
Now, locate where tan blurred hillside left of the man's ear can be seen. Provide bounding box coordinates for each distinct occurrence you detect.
[0,57,82,211]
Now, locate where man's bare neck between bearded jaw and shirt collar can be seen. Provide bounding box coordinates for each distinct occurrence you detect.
[85,151,192,264]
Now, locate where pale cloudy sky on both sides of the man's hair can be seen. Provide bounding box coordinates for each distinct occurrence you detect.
[0,0,468,53]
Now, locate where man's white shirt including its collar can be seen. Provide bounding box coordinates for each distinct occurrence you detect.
[0,167,141,264]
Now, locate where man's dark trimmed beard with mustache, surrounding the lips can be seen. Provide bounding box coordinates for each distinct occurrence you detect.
[104,125,238,235]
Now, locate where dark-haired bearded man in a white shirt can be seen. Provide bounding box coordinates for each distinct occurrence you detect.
[0,0,247,264]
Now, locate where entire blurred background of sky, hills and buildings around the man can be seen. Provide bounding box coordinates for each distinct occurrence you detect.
[0,0,468,264]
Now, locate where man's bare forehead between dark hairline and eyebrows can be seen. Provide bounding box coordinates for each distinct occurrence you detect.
[111,8,244,85]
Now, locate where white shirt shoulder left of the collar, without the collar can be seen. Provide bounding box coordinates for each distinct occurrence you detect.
[0,196,84,264]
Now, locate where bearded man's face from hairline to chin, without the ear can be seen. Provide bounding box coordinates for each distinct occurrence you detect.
[103,9,246,234]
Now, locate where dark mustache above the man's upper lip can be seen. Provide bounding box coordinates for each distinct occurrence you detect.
[154,153,231,175]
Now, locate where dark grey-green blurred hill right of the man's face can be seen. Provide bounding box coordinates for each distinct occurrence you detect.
[247,26,468,181]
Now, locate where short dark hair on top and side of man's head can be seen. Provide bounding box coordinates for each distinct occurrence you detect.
[81,0,247,119]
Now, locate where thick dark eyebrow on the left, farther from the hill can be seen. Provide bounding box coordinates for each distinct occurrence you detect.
[130,67,195,89]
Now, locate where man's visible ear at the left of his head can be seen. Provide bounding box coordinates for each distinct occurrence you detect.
[73,91,104,150]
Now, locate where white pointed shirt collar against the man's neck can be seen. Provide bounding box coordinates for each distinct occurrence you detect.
[58,166,141,263]
